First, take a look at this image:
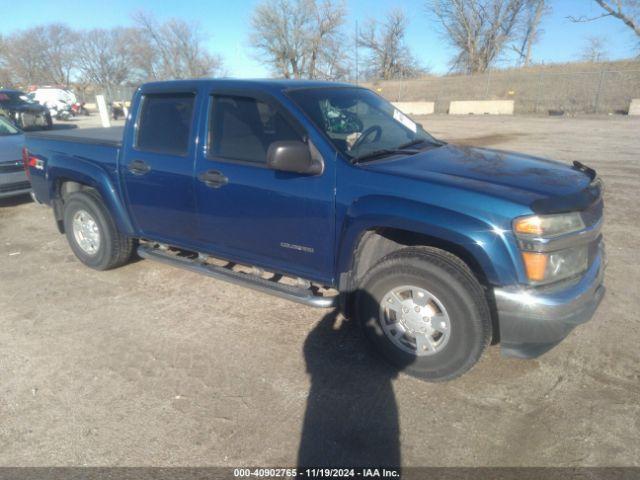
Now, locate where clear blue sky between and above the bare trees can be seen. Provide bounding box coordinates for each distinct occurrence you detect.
[0,0,637,77]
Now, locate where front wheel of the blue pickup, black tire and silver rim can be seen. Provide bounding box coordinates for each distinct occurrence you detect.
[355,247,491,382]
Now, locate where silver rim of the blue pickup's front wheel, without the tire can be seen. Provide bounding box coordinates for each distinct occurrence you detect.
[380,285,451,357]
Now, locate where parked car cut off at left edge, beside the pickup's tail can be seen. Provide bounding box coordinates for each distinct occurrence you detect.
[0,116,31,198]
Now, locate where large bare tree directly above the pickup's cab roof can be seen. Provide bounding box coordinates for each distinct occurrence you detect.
[249,0,347,79]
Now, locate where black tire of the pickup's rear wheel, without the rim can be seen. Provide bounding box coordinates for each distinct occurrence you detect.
[63,191,134,270]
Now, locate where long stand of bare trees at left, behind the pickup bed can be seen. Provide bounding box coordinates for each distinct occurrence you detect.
[0,12,224,90]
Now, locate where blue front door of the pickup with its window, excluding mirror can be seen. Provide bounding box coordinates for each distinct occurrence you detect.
[195,92,334,282]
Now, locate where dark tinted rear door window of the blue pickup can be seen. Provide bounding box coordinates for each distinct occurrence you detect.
[136,93,195,155]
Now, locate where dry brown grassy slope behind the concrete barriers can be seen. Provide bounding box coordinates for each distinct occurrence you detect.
[363,69,640,115]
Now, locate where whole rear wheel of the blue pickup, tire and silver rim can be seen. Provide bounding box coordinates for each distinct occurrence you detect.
[63,191,134,270]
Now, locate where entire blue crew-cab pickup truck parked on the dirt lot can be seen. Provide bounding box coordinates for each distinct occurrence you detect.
[23,80,605,381]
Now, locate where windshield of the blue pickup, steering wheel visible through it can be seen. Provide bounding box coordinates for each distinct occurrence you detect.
[287,87,440,160]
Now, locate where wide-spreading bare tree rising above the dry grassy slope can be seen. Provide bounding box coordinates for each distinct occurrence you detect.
[427,0,527,73]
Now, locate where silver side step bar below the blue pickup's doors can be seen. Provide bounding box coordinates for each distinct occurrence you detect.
[138,245,338,308]
